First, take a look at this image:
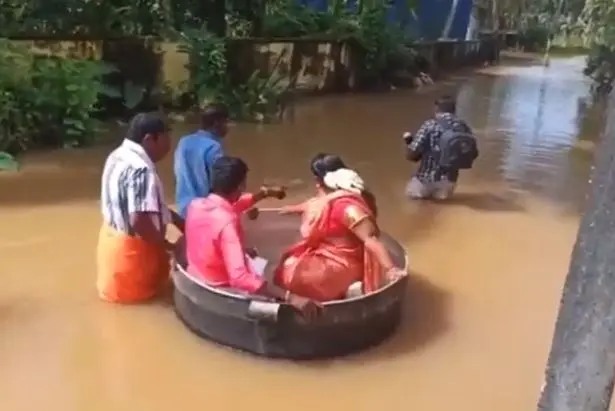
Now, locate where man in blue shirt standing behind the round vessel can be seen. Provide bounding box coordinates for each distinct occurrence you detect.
[174,104,229,218]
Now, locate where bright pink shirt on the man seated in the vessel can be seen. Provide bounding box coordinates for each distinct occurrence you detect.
[185,194,264,293]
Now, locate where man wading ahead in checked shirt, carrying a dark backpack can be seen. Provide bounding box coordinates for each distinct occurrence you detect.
[403,96,478,200]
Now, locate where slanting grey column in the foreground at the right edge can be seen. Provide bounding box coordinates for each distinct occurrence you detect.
[538,100,615,411]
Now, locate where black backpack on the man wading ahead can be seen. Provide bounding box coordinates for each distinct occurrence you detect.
[436,120,478,170]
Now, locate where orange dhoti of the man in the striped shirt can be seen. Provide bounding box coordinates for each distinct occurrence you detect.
[96,223,170,303]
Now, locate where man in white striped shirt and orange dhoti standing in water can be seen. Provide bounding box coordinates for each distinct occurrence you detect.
[97,113,183,303]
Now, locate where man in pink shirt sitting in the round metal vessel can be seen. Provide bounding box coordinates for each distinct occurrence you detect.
[185,157,320,317]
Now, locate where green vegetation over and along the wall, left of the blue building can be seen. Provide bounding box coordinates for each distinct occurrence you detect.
[0,0,424,159]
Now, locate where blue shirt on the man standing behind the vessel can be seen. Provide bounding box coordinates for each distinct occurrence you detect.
[174,130,224,217]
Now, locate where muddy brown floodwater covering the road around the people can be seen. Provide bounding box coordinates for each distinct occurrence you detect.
[0,58,603,411]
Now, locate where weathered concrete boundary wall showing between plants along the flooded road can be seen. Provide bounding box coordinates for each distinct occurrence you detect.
[8,39,500,106]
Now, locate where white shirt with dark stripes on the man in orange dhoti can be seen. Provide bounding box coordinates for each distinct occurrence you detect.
[100,140,170,235]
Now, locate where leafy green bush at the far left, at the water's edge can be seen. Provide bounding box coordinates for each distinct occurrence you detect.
[0,40,118,152]
